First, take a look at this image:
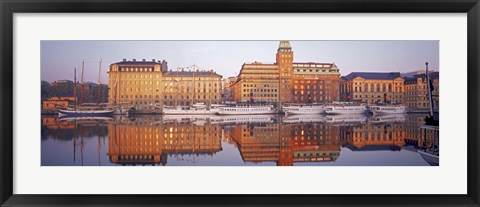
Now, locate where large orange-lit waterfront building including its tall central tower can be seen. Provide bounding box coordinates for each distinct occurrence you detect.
[231,41,340,104]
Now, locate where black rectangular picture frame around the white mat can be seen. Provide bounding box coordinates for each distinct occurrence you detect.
[0,0,480,206]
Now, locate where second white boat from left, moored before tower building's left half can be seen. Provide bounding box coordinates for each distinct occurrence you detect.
[218,105,277,115]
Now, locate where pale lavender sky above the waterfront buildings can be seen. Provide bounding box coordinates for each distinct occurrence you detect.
[41,40,439,83]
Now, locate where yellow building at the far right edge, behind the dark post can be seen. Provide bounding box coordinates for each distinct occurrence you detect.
[405,72,440,112]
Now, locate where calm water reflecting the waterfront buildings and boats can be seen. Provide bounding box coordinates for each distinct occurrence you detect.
[41,114,438,166]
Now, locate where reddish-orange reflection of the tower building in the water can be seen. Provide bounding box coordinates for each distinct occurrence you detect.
[228,118,340,166]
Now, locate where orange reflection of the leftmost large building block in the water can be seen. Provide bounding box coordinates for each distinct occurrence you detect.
[108,117,222,165]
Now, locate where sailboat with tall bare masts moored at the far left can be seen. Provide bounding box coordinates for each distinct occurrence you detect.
[58,62,117,117]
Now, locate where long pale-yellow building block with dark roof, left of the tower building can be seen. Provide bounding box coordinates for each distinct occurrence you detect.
[108,59,222,110]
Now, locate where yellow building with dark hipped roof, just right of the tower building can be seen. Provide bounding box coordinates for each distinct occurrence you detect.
[340,72,405,104]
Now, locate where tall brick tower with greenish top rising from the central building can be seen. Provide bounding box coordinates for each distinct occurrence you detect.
[277,41,293,106]
